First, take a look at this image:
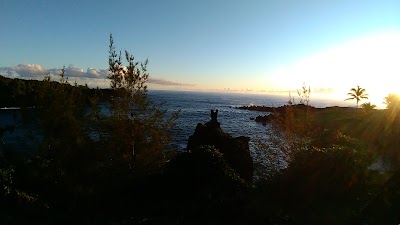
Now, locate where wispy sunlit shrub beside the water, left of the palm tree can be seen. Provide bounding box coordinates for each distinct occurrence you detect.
[255,83,315,179]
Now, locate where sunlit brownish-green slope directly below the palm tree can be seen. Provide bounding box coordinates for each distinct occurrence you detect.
[311,107,400,169]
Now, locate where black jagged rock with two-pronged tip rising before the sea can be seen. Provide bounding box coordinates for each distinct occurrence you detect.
[187,110,253,181]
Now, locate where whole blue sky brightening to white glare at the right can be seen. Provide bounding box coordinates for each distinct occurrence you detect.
[0,0,400,104]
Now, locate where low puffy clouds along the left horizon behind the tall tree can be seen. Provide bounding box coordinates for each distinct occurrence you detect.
[0,64,196,87]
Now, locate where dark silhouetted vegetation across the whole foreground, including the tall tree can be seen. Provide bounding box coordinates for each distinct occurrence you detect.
[0,36,400,224]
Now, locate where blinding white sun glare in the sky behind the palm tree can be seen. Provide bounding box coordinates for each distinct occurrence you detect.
[267,32,400,108]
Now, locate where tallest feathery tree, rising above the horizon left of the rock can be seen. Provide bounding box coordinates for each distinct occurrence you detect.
[104,34,177,173]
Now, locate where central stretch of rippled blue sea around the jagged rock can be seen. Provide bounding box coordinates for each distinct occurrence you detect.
[150,91,285,150]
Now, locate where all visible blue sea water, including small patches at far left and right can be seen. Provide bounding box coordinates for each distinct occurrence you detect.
[0,91,344,150]
